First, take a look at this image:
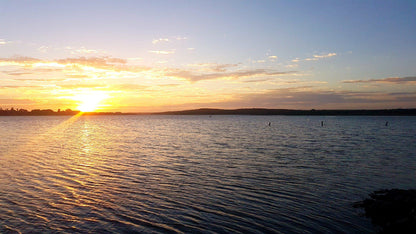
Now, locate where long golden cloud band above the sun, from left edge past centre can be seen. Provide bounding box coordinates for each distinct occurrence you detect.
[0,56,297,82]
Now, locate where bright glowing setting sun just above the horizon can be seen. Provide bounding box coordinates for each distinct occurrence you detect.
[73,91,108,112]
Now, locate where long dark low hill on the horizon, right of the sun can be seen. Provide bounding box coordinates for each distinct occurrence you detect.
[154,108,416,116]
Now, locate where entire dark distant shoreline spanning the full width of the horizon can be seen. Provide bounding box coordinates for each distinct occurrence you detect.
[0,108,416,116]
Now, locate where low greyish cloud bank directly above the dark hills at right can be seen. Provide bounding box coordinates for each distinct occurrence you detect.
[213,86,416,109]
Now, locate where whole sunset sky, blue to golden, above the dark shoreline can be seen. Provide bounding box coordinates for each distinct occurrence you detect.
[0,0,416,112]
